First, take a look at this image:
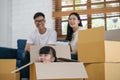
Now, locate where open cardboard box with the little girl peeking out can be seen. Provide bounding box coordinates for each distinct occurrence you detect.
[11,45,87,80]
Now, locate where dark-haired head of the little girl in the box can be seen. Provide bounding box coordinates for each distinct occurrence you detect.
[39,46,57,63]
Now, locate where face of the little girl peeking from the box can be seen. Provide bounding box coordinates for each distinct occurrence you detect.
[39,54,55,63]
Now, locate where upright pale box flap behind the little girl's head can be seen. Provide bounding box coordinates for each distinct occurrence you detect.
[30,45,71,62]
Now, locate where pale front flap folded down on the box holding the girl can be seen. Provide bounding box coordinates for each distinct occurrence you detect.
[35,62,88,80]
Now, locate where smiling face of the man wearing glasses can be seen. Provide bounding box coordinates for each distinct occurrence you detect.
[34,16,45,30]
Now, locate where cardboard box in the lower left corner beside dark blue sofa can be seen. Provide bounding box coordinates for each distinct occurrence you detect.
[0,59,20,80]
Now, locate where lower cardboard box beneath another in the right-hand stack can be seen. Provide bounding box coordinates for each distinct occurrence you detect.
[85,63,120,80]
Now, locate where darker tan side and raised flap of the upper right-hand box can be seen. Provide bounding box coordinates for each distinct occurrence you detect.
[78,27,105,63]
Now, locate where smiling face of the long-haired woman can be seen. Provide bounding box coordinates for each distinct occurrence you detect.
[68,15,80,28]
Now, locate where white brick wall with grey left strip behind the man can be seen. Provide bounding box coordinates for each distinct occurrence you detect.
[0,0,54,48]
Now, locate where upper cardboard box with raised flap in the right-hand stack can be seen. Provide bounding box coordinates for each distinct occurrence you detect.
[78,27,120,63]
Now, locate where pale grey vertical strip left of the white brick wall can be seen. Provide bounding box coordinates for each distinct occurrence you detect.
[0,0,12,47]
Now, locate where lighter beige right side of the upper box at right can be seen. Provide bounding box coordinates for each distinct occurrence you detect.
[104,41,120,62]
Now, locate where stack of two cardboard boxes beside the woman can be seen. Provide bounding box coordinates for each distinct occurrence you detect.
[78,27,120,80]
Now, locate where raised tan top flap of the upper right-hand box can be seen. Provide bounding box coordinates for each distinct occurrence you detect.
[78,27,104,43]
